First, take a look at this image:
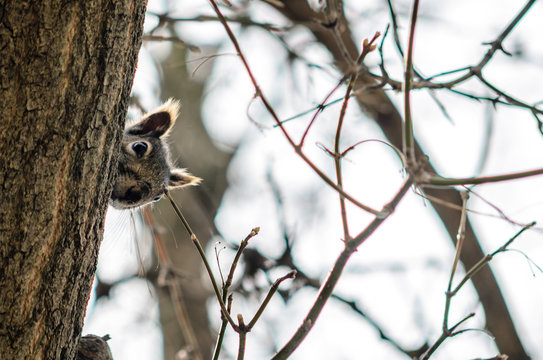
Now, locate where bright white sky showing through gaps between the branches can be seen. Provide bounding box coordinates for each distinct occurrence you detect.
[84,0,543,360]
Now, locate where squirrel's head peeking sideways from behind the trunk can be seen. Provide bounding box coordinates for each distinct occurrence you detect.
[110,99,201,209]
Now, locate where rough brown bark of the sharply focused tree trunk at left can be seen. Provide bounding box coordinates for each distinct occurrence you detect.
[0,0,146,359]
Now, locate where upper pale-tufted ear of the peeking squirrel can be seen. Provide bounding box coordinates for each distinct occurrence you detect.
[126,99,180,137]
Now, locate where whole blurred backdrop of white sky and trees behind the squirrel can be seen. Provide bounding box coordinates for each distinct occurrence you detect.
[83,0,543,360]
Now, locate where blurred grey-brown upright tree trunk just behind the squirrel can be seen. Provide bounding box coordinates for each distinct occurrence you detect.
[157,43,231,359]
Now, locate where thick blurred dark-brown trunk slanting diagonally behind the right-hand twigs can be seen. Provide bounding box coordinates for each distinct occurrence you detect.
[278,0,529,359]
